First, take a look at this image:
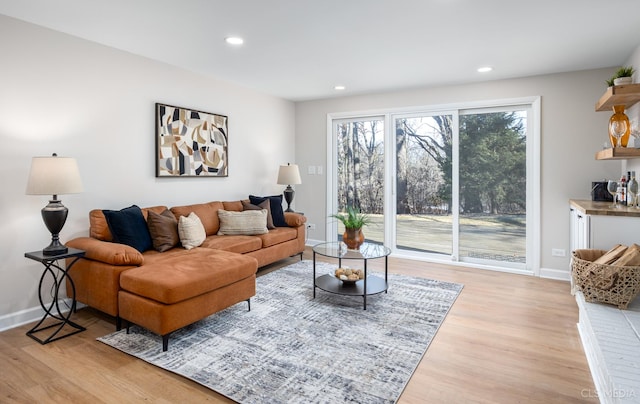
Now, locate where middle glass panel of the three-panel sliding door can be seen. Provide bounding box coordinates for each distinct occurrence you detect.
[394,114,454,255]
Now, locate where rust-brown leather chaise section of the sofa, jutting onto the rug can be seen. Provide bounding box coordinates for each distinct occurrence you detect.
[118,248,258,351]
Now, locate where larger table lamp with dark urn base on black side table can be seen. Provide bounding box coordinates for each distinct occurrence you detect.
[27,153,82,255]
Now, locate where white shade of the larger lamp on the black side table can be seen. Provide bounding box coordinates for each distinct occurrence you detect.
[27,156,82,195]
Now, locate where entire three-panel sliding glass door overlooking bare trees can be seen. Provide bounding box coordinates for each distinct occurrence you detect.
[328,99,539,271]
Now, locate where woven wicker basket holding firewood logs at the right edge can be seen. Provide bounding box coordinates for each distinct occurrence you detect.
[571,250,640,310]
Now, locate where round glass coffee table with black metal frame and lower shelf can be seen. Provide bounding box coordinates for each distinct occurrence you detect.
[313,241,391,310]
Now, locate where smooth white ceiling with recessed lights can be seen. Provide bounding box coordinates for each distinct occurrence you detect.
[0,0,640,101]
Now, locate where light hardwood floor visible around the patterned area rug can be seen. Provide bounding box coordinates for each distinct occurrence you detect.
[0,249,598,404]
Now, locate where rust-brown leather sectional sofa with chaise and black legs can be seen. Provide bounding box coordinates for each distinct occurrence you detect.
[66,201,306,350]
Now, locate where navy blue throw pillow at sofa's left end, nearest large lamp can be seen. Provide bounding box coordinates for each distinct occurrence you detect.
[102,205,153,252]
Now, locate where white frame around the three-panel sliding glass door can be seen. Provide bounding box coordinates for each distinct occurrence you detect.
[325,96,541,276]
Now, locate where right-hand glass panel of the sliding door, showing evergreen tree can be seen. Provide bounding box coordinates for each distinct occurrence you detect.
[458,109,527,264]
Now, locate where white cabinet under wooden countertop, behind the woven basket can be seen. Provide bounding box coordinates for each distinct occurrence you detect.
[570,206,640,251]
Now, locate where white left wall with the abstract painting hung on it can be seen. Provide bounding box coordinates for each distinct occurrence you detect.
[0,15,302,329]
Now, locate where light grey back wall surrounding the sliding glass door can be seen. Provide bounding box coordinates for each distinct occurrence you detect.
[296,68,620,279]
